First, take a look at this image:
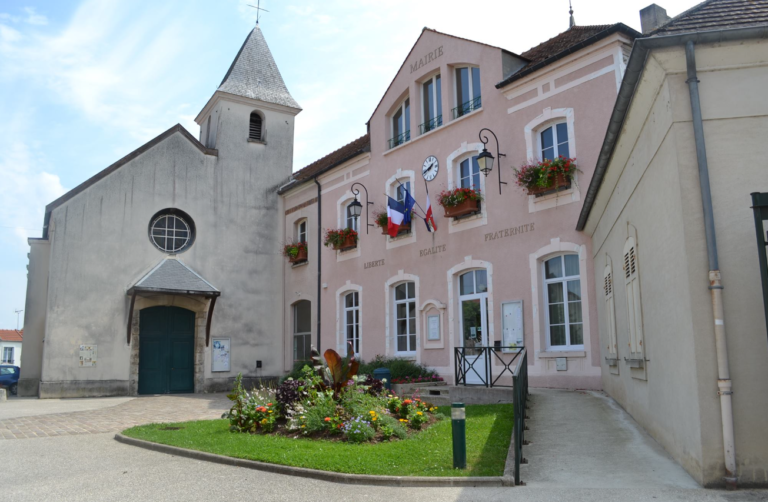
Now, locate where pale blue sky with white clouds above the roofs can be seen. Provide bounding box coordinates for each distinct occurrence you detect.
[0,0,697,329]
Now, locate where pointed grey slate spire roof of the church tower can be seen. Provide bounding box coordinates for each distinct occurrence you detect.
[218,25,301,110]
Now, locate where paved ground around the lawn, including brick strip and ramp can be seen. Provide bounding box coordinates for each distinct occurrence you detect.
[0,390,768,502]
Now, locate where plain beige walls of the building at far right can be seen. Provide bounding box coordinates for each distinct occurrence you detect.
[587,43,768,485]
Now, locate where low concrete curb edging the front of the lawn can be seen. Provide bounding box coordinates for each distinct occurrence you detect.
[115,433,515,487]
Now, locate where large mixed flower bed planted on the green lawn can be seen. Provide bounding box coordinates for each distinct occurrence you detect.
[222,345,441,443]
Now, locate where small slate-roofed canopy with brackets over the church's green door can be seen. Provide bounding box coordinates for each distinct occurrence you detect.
[127,256,221,347]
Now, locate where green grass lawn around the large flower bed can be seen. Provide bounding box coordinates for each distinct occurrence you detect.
[123,404,513,476]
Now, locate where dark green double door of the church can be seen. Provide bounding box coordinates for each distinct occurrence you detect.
[139,307,195,394]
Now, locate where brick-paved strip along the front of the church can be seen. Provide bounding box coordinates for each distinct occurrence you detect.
[0,394,230,440]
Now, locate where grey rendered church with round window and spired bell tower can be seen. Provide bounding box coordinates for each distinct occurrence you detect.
[19,26,301,397]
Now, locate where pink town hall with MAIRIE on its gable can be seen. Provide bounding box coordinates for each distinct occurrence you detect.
[280,24,639,389]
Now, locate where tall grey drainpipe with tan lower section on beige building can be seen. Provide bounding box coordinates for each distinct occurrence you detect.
[685,41,737,489]
